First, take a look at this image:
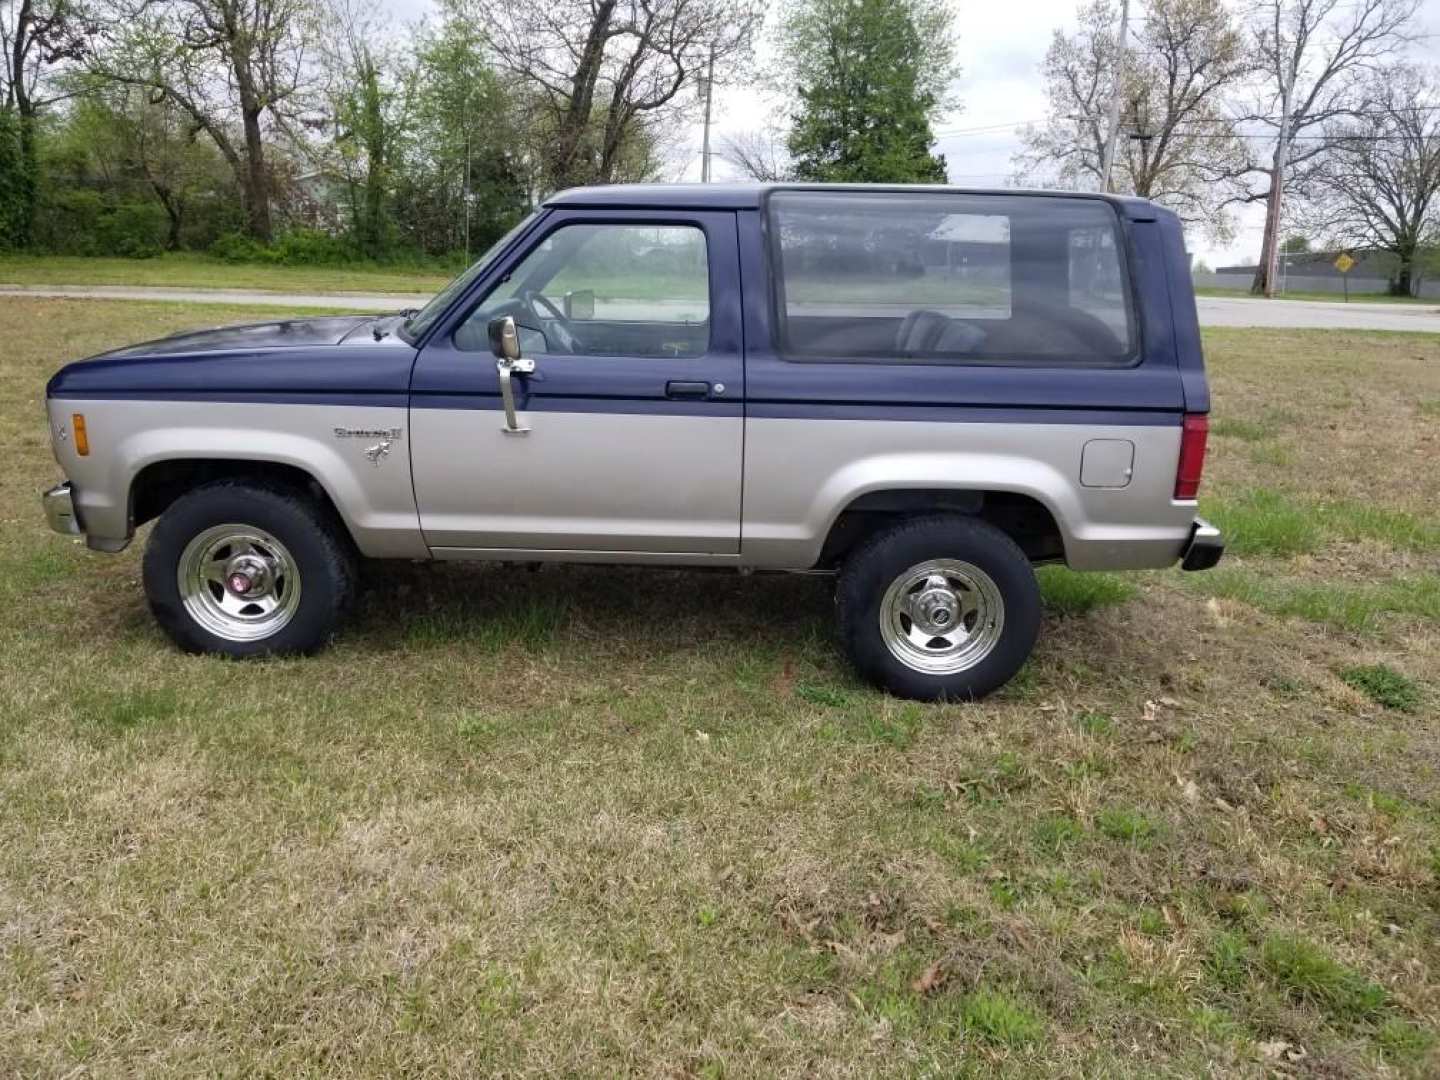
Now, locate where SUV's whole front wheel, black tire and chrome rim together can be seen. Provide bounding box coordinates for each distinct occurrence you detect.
[144,481,356,657]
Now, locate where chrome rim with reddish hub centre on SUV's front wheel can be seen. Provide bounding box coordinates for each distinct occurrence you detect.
[177,526,300,641]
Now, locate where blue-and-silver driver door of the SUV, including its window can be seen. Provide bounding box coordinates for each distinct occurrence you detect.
[410,210,744,556]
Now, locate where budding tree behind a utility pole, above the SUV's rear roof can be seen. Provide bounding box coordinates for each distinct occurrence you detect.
[1015,0,1251,239]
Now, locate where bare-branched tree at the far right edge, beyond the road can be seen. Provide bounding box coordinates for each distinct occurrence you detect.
[1310,66,1440,297]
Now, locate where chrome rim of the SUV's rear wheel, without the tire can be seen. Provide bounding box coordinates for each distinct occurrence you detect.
[880,559,1005,675]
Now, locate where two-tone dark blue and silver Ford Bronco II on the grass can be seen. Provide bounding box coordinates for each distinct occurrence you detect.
[45,186,1223,698]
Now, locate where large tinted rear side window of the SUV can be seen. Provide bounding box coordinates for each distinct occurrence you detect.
[770,192,1135,364]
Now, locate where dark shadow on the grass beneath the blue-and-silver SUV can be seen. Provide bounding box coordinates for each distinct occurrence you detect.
[336,563,1157,698]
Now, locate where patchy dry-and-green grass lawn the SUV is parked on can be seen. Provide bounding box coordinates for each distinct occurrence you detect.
[0,300,1440,1077]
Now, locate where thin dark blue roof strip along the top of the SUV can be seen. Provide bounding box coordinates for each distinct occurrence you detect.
[544,183,1153,216]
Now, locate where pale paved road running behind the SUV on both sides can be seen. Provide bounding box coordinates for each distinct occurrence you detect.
[0,285,1440,334]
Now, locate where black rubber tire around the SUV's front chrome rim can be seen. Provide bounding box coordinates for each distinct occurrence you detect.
[144,480,357,658]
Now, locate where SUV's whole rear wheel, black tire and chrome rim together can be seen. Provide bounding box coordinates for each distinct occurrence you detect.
[835,516,1040,700]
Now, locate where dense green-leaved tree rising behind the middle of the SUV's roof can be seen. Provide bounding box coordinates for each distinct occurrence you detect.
[779,0,958,183]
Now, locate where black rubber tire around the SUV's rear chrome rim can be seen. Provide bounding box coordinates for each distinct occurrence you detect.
[835,514,1040,701]
